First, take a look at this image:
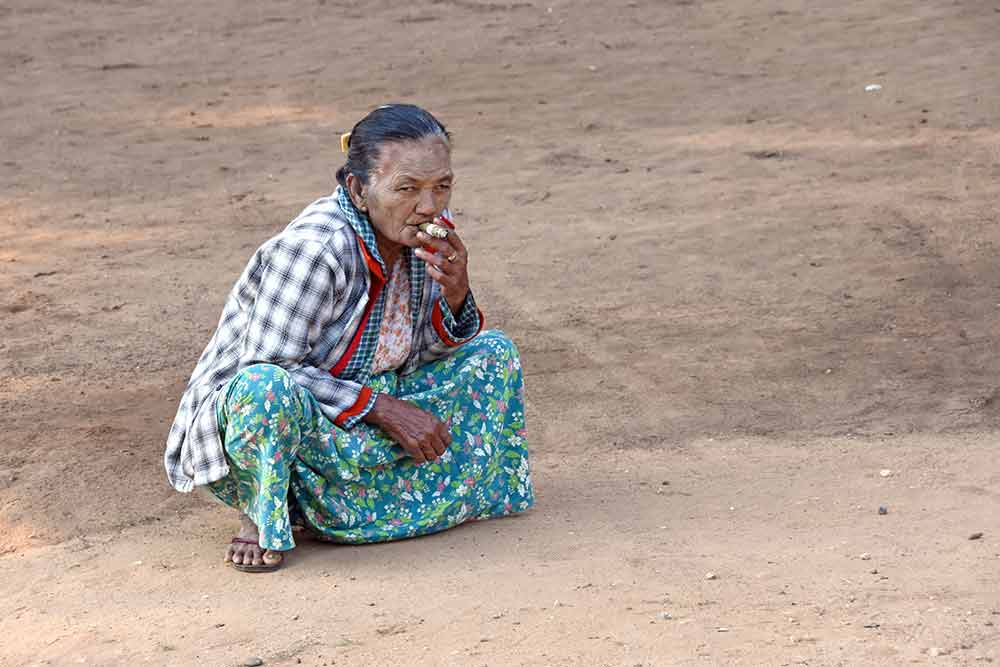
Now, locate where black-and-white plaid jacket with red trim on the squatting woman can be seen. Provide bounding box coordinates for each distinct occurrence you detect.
[164,188,483,492]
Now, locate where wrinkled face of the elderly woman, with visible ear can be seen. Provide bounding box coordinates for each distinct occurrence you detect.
[348,136,454,248]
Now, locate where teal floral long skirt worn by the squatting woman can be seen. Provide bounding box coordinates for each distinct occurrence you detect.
[208,330,534,551]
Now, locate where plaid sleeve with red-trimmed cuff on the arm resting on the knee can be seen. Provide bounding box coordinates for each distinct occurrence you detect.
[240,239,375,428]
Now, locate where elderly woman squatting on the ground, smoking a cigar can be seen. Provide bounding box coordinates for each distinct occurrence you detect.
[165,104,534,572]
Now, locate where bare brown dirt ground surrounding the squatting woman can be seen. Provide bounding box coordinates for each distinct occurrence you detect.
[0,0,1000,667]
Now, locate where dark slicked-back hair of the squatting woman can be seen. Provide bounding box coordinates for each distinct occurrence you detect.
[337,104,451,188]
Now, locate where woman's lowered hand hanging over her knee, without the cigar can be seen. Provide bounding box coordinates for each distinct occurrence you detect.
[364,394,451,463]
